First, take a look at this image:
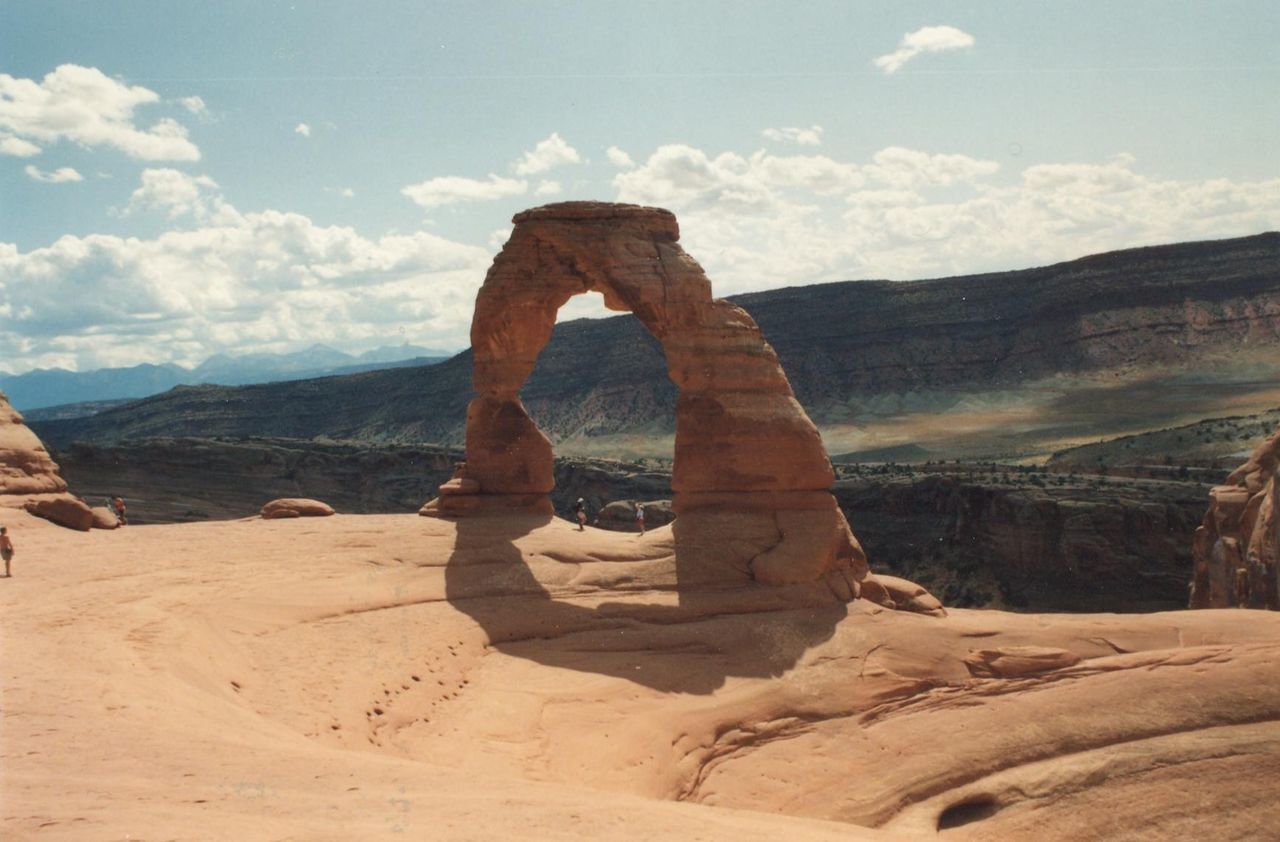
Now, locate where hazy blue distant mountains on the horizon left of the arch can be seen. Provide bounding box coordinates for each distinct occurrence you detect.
[0,344,453,412]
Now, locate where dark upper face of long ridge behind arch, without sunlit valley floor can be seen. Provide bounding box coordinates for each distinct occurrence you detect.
[27,233,1280,445]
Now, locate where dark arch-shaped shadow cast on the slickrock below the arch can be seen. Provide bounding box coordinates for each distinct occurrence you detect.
[444,516,849,694]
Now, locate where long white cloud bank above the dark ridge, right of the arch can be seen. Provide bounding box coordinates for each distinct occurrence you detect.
[613,146,1280,294]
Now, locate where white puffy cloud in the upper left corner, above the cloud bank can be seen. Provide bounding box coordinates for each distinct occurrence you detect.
[0,64,200,161]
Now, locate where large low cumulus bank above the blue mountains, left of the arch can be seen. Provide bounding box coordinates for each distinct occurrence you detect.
[0,197,492,370]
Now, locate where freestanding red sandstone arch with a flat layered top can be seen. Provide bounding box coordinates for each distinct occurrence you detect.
[424,202,885,586]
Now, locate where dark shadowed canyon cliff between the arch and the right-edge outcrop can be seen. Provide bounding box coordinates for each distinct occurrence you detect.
[833,468,1207,612]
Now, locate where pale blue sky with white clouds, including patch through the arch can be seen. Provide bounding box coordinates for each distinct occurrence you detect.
[0,0,1280,374]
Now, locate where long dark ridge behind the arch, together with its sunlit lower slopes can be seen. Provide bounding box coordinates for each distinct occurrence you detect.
[32,233,1280,461]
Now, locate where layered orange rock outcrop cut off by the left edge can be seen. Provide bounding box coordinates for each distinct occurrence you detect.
[0,392,93,530]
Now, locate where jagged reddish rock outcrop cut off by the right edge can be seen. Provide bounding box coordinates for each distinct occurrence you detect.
[1190,430,1280,610]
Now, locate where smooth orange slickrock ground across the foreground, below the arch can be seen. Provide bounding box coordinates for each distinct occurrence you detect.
[0,514,1280,842]
